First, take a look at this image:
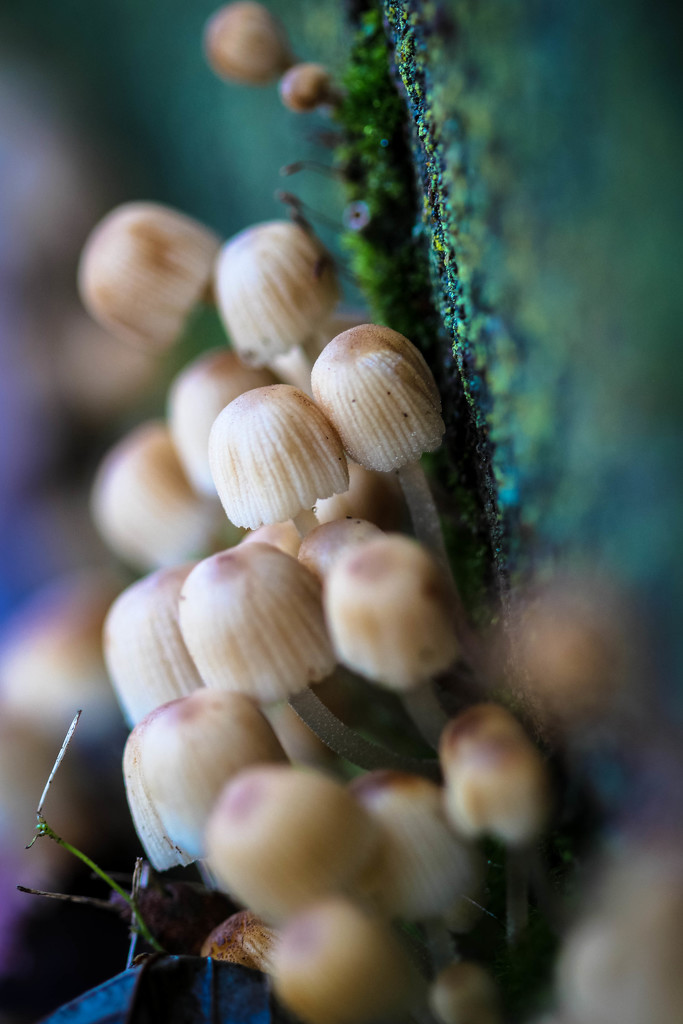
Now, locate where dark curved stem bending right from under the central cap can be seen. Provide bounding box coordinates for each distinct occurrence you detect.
[289,688,440,781]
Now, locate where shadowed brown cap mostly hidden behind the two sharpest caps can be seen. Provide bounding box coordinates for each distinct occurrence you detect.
[314,462,405,531]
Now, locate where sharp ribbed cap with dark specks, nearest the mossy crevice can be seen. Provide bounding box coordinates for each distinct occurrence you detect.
[311,324,445,472]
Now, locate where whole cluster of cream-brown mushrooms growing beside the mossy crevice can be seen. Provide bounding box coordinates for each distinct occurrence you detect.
[62,2,573,1024]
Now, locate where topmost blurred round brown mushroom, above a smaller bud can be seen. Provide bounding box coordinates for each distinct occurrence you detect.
[204,0,294,85]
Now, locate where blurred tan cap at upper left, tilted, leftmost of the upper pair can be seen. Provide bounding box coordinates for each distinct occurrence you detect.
[78,203,220,351]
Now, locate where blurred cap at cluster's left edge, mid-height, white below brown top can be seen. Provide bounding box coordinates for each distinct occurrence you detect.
[91,421,220,570]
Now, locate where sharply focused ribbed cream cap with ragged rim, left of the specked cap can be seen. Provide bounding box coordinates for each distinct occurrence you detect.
[209,384,348,529]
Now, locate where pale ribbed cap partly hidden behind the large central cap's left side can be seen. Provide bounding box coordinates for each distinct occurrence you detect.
[104,562,204,725]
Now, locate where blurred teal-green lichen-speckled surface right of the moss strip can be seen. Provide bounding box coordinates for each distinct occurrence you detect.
[384,0,683,688]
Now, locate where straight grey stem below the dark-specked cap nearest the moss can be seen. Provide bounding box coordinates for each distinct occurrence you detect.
[396,461,484,672]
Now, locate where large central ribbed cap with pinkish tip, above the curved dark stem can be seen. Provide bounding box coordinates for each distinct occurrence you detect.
[180,544,335,701]
